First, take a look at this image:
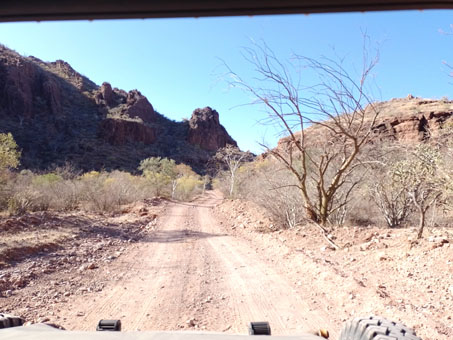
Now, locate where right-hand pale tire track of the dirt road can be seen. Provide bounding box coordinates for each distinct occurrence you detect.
[192,193,335,336]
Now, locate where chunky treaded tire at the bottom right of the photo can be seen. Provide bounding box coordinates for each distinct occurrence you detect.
[339,316,421,340]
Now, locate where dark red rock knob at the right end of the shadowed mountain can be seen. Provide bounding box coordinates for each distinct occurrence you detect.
[187,107,237,151]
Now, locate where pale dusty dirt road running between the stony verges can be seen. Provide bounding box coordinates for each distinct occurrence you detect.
[63,192,333,335]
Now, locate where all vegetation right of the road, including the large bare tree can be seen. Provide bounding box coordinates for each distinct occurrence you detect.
[216,43,452,244]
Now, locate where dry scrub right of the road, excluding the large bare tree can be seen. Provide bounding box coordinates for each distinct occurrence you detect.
[215,143,452,238]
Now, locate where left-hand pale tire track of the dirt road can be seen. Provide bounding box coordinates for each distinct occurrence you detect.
[63,204,207,330]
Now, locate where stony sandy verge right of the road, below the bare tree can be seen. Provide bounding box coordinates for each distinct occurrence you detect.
[216,200,453,340]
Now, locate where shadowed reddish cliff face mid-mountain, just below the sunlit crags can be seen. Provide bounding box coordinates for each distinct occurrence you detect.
[99,119,157,145]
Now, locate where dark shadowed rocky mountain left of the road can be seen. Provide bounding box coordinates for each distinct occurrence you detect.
[0,45,236,171]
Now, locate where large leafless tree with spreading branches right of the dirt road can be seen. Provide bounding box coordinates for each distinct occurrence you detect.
[225,41,379,233]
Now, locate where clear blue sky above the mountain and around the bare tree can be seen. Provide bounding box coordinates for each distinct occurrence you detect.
[0,11,453,153]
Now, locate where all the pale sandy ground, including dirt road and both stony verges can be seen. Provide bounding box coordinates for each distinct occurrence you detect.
[0,192,453,340]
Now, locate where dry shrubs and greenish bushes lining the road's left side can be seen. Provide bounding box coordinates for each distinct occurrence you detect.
[0,134,204,215]
